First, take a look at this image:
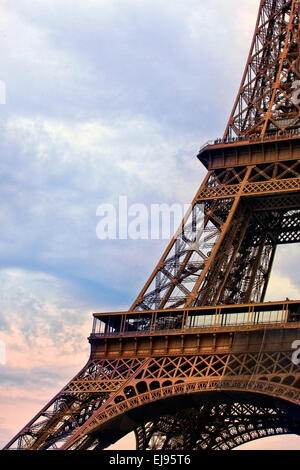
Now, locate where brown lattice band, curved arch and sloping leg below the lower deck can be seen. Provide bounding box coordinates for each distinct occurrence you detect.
[6,351,300,450]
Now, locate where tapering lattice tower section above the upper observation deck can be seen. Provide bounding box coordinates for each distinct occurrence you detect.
[223,0,300,142]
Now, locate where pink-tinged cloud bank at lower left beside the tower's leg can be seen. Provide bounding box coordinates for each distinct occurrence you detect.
[0,269,92,444]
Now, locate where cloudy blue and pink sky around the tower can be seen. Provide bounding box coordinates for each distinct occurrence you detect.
[0,0,300,449]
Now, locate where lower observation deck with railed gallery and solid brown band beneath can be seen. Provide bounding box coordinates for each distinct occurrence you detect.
[89,300,300,360]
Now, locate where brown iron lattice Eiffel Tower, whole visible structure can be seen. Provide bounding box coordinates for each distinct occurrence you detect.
[5,0,300,451]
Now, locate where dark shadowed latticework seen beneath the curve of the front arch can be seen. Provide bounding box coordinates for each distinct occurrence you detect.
[135,402,300,451]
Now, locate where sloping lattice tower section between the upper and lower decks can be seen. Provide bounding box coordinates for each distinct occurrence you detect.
[130,160,300,310]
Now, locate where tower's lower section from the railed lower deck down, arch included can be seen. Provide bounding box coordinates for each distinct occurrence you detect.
[5,301,300,450]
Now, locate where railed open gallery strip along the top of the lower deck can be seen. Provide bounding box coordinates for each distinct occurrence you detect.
[91,300,300,338]
